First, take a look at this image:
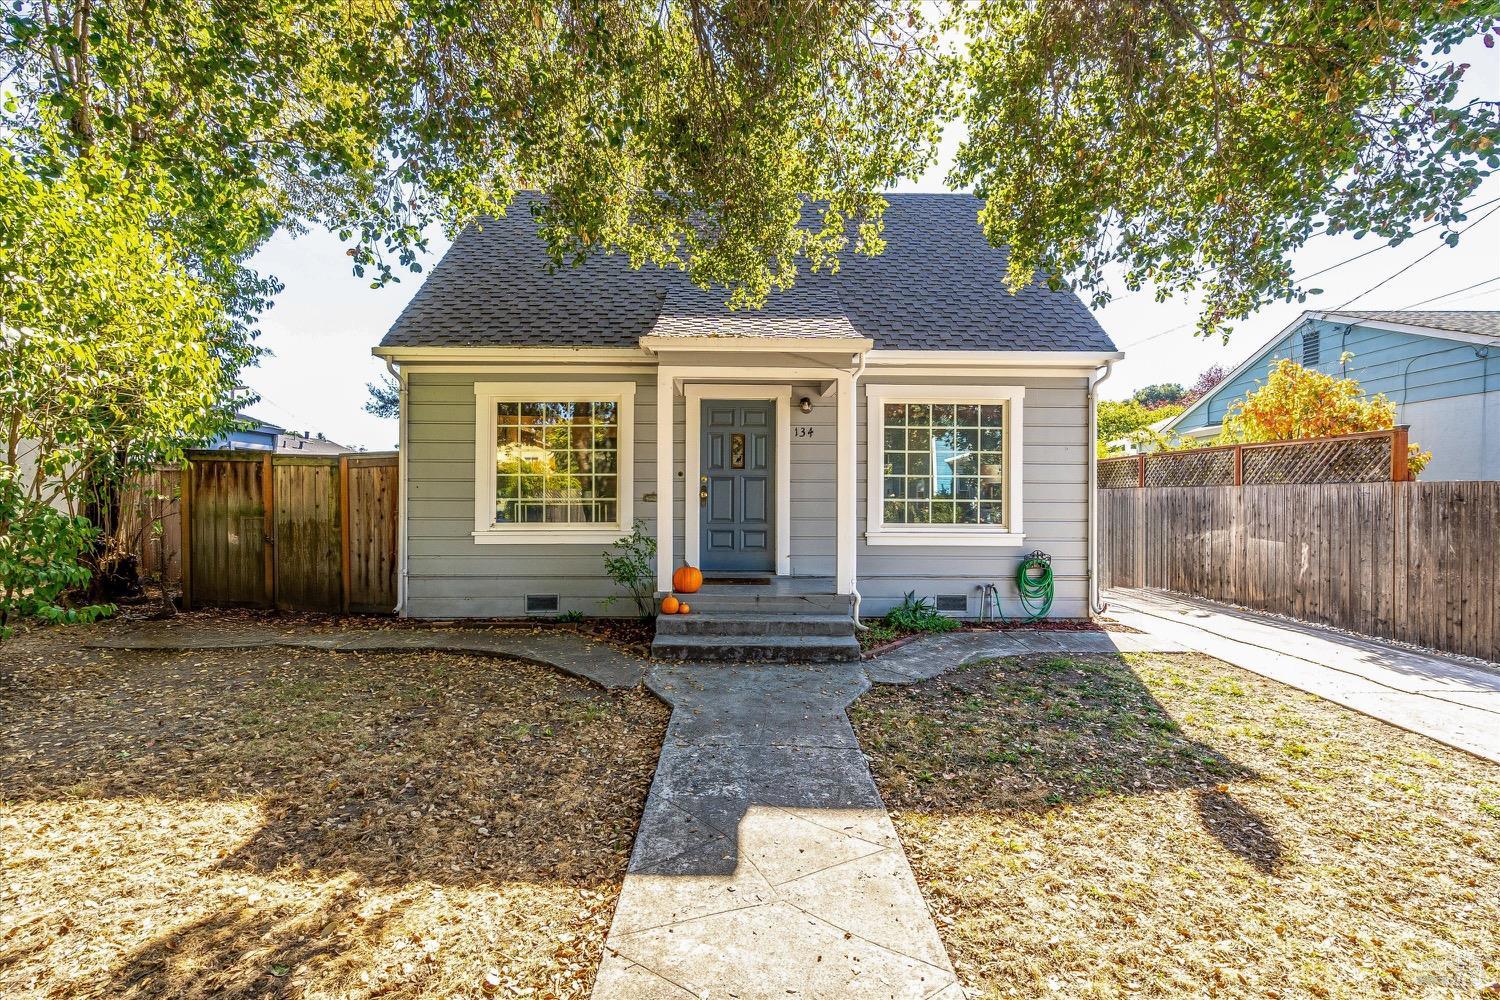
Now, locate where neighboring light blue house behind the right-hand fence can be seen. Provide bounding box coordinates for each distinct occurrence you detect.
[1164,310,1500,480]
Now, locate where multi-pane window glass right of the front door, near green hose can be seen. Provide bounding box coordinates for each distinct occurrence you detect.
[879,400,1007,525]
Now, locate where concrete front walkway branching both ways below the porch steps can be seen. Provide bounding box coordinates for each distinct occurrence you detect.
[89,622,1181,1000]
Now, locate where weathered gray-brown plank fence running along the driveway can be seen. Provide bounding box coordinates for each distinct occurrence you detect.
[1100,481,1500,660]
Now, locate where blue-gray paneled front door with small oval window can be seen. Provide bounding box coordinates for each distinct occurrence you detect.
[699,399,777,573]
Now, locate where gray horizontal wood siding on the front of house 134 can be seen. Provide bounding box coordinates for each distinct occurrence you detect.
[407,366,1089,618]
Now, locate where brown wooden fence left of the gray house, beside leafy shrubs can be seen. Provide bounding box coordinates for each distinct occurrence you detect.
[122,451,399,612]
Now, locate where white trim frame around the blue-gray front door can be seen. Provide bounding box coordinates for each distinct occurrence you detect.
[684,375,792,575]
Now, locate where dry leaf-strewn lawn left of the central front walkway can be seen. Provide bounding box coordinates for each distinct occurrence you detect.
[0,630,668,999]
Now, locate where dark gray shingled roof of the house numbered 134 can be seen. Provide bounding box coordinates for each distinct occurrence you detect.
[381,195,1115,351]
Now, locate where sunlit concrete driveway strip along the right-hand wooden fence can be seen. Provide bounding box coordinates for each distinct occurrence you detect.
[1106,591,1500,763]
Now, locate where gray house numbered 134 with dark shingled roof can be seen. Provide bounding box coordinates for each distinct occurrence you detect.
[375,195,1121,656]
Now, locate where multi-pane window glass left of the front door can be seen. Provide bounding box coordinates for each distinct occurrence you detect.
[494,399,620,525]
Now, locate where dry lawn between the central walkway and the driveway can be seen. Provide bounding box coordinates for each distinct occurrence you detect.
[855,655,1500,999]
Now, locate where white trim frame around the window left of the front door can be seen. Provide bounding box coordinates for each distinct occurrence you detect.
[474,381,636,546]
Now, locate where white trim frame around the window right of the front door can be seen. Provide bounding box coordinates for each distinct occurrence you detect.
[864,382,1026,546]
